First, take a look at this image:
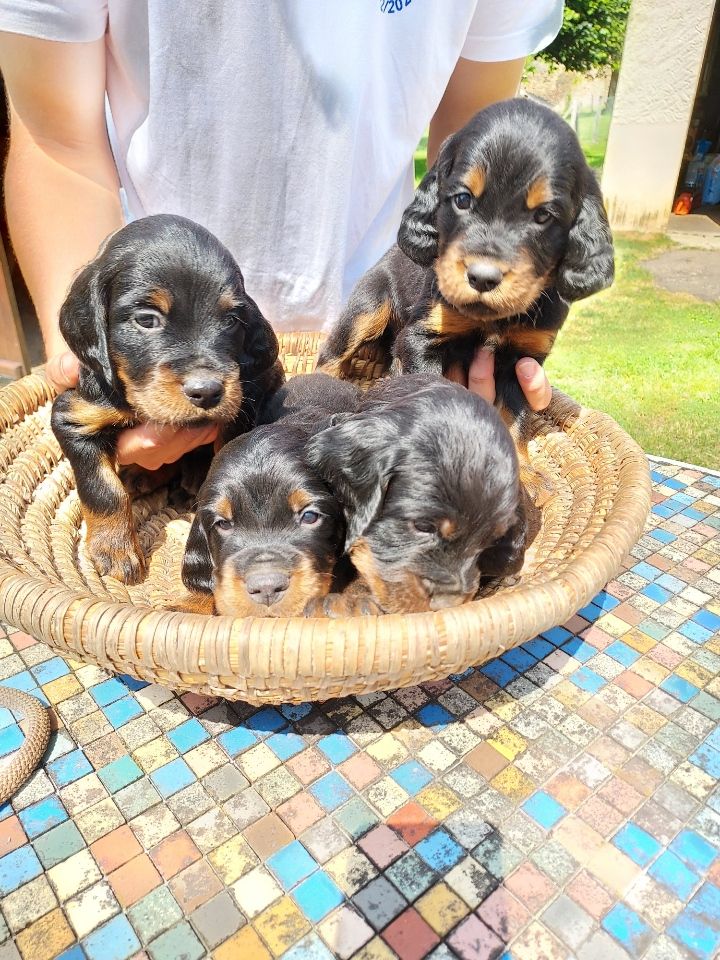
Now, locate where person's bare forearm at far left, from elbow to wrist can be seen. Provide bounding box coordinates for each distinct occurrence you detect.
[5,110,122,356]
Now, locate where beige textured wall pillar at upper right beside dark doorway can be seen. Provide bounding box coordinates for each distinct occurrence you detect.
[602,0,715,231]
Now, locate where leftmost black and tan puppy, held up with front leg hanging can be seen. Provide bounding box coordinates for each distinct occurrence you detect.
[52,215,283,583]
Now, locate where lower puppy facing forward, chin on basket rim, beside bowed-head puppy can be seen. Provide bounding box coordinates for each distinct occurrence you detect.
[182,374,359,617]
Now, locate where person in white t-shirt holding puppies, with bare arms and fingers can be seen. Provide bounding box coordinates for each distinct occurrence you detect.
[0,0,563,469]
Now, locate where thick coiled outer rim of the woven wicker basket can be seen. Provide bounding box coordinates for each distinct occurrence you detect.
[0,374,651,695]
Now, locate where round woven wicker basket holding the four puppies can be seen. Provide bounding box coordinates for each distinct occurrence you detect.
[0,334,650,703]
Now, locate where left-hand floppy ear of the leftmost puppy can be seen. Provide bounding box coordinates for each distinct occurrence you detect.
[60,260,115,384]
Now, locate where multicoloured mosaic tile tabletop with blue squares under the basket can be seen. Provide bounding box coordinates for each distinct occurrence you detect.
[0,463,720,960]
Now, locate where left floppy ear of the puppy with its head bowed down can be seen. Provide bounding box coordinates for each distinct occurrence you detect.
[305,414,399,549]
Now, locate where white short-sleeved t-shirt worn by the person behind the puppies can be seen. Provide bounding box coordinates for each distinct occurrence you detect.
[0,0,563,330]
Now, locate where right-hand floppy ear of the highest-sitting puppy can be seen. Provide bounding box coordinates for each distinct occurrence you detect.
[556,167,615,301]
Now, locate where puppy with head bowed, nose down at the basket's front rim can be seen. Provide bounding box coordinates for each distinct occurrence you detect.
[306,374,527,613]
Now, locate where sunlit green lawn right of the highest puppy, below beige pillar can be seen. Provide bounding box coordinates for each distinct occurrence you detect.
[546,238,720,470]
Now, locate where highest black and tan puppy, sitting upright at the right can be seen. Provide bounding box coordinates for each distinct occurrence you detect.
[320,99,614,421]
